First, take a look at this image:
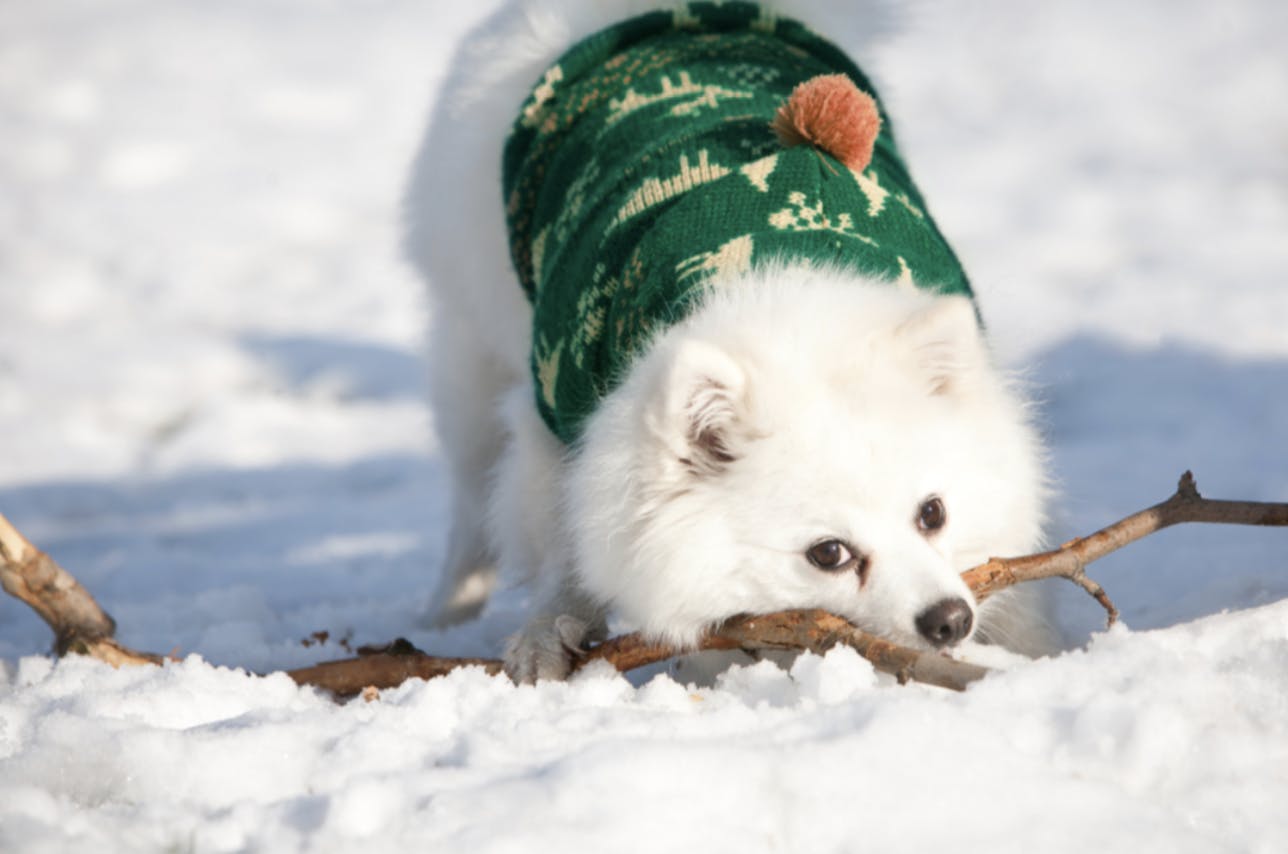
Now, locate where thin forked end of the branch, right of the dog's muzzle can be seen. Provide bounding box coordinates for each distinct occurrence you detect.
[962,471,1288,625]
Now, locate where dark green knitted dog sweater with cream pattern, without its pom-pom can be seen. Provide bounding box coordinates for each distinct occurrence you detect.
[502,3,970,442]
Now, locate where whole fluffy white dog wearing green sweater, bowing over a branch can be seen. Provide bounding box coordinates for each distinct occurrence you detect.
[407,0,1048,680]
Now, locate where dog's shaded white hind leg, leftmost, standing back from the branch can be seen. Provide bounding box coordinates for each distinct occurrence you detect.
[422,320,510,629]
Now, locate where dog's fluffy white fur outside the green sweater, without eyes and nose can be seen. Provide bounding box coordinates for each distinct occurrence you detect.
[407,0,1048,679]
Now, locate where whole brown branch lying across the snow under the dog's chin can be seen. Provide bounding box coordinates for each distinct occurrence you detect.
[0,471,1288,696]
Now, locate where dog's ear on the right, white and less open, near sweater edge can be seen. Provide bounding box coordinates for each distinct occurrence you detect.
[896,295,988,395]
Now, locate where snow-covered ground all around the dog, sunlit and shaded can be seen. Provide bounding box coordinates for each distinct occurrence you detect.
[0,0,1288,851]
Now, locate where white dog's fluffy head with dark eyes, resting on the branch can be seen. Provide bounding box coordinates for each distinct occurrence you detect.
[567,268,1043,647]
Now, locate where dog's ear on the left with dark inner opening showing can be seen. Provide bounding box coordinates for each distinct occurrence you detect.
[649,340,747,474]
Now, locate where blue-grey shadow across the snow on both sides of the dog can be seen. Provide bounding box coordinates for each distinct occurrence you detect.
[0,337,1288,669]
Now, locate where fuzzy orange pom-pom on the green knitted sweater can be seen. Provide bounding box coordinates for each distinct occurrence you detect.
[772,75,881,171]
